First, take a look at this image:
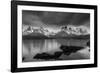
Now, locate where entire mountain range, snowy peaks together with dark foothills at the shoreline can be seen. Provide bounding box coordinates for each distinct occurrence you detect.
[22,26,90,38]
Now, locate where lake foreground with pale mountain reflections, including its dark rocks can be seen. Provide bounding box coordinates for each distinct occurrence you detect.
[22,39,90,62]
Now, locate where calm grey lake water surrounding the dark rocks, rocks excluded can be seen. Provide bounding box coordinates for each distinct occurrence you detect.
[22,39,90,62]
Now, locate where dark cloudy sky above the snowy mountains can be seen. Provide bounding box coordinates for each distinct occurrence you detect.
[22,10,90,26]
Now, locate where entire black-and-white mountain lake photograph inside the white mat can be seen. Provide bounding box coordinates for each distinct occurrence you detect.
[22,10,90,62]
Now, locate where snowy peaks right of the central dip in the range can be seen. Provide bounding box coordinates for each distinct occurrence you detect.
[61,25,90,35]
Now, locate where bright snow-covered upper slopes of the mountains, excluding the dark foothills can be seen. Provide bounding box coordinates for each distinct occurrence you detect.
[23,25,90,37]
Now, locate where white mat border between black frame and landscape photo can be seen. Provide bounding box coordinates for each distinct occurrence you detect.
[17,5,94,68]
